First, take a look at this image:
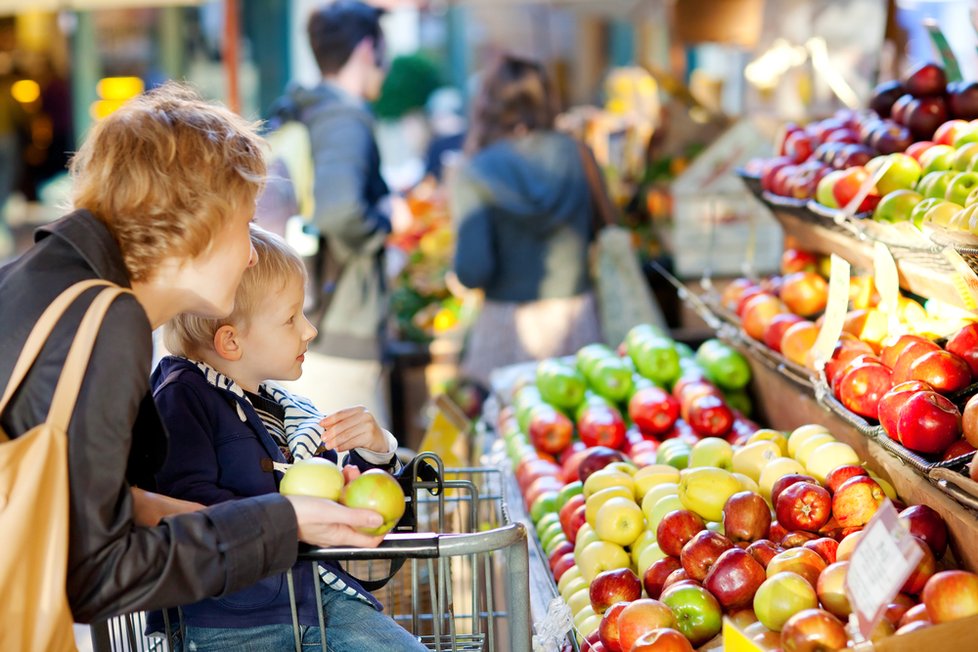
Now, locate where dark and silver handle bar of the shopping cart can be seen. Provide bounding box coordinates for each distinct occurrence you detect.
[298,522,527,561]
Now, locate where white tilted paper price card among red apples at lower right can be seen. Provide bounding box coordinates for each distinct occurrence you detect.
[846,500,923,639]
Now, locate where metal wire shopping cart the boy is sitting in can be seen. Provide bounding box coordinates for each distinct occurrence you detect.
[92,453,531,652]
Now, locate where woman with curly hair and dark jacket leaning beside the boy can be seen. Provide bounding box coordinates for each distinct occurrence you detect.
[0,84,382,623]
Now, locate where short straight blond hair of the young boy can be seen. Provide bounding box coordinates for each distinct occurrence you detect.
[163,226,306,358]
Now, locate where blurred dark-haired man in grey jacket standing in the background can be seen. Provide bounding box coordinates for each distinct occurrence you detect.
[279,0,410,425]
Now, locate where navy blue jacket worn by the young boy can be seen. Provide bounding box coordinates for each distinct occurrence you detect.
[147,357,388,631]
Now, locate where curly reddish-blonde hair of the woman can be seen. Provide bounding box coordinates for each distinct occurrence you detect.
[69,82,266,281]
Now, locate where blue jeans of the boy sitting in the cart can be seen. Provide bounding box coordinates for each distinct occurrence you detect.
[173,586,428,652]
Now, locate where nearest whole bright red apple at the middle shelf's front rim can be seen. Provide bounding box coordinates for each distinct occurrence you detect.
[897,391,961,453]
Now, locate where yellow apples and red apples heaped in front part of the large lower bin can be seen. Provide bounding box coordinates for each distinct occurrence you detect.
[516,415,978,652]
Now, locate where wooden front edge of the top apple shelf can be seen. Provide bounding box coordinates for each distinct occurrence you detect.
[771,206,968,310]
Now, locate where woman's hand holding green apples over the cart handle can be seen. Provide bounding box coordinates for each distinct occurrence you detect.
[287,496,384,548]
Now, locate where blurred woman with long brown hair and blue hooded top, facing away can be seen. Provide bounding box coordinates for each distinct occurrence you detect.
[451,55,600,385]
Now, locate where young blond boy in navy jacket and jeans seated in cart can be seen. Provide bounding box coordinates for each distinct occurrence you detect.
[151,228,425,652]
